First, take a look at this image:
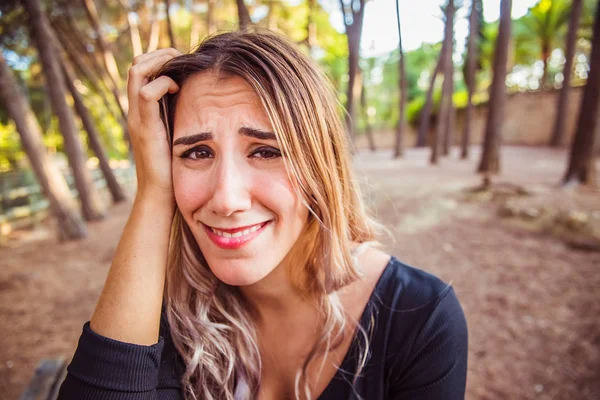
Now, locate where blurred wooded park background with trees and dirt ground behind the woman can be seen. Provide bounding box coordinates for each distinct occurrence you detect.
[0,0,600,400]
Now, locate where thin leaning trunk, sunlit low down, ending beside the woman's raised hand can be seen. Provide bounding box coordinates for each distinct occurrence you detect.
[82,0,129,117]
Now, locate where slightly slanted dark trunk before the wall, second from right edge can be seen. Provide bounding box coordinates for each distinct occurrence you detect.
[550,0,583,147]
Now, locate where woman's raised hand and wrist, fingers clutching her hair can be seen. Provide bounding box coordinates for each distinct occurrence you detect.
[127,49,181,204]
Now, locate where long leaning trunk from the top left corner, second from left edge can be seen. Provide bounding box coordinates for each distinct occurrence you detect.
[23,0,104,221]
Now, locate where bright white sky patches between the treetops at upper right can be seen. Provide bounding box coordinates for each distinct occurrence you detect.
[320,0,539,56]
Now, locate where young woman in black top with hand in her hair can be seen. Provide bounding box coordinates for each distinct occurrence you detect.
[59,32,467,400]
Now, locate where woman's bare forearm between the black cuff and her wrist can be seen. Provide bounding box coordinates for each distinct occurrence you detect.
[90,193,175,345]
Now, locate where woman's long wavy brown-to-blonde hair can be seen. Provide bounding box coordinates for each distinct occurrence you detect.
[158,32,377,400]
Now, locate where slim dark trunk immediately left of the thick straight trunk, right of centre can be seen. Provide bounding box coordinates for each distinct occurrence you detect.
[460,0,481,160]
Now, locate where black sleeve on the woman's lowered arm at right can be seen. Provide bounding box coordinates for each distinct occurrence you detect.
[387,287,468,400]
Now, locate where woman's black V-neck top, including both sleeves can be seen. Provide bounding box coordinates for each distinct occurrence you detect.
[58,257,468,400]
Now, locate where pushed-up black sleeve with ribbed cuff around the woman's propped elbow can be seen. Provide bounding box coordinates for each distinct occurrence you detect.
[58,321,182,400]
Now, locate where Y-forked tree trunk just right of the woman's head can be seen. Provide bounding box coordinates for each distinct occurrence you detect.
[340,0,365,138]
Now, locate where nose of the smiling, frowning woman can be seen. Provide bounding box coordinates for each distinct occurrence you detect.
[207,159,252,217]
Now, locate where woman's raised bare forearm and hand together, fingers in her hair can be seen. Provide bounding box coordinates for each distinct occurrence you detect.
[90,49,179,345]
